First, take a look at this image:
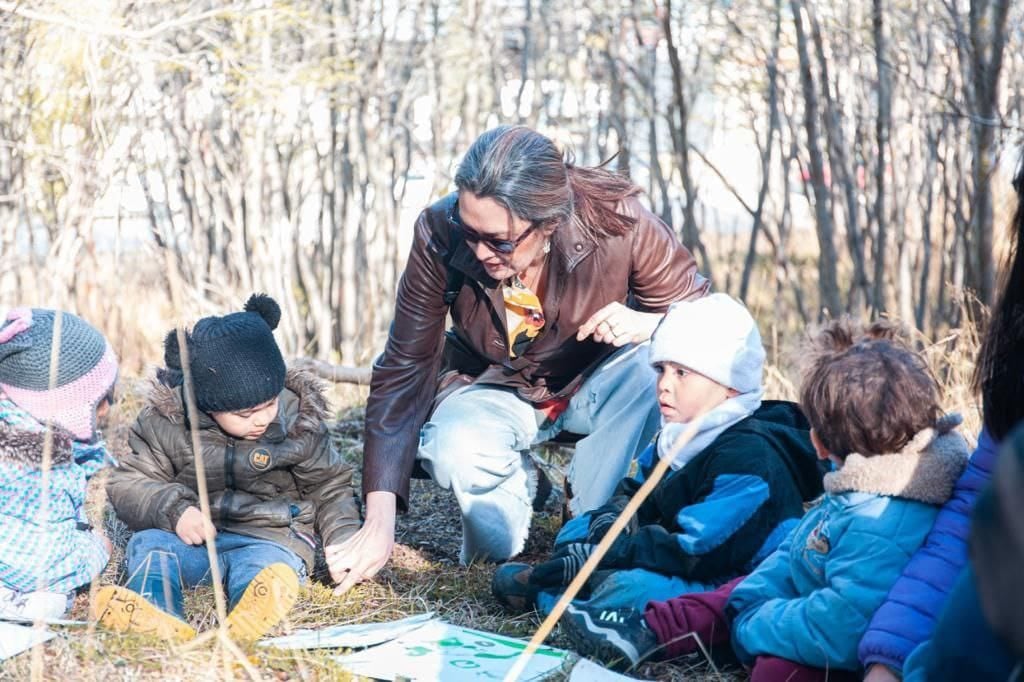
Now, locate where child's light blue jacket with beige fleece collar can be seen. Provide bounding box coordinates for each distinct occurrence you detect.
[726,420,967,671]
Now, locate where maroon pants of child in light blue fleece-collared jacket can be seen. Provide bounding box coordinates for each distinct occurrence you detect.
[644,577,860,682]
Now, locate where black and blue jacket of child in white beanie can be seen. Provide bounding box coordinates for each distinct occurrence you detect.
[589,400,827,582]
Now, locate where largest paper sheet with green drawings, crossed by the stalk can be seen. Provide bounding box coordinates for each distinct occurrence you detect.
[337,621,570,682]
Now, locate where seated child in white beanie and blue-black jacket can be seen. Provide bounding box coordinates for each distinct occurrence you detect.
[493,294,823,655]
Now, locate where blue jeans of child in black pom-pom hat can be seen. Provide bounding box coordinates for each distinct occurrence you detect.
[127,528,306,617]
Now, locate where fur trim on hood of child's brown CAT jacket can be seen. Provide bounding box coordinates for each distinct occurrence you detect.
[146,369,330,439]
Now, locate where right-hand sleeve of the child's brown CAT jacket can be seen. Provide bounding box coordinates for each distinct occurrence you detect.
[292,425,360,546]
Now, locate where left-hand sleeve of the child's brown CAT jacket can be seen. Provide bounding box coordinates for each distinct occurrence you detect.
[106,408,199,532]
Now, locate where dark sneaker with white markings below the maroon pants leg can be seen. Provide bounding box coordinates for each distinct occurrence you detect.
[561,604,658,672]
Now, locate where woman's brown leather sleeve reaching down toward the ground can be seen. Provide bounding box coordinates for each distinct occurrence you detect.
[362,209,447,509]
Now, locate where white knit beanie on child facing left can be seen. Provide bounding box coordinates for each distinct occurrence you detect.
[650,294,765,393]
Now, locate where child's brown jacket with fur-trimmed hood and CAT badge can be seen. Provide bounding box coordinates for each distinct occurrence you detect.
[106,370,359,570]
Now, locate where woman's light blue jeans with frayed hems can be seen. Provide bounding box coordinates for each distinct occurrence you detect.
[418,343,660,564]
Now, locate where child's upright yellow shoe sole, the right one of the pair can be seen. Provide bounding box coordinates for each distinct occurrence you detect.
[227,563,299,642]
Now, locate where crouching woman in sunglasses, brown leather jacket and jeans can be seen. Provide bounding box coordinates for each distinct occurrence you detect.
[331,126,708,590]
